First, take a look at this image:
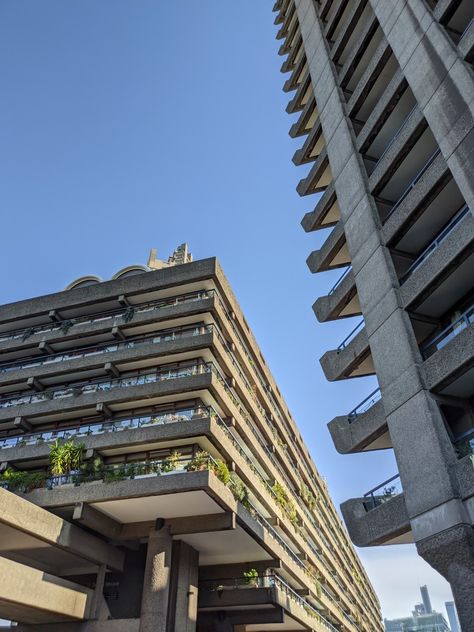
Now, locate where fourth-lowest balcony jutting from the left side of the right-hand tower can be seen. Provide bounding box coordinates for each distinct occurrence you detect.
[313,268,362,323]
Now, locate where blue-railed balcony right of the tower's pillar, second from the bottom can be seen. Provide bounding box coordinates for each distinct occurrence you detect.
[421,306,474,399]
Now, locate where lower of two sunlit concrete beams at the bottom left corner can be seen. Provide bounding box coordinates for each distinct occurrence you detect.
[0,557,93,624]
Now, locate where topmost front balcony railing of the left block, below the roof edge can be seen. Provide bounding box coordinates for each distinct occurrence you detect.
[0,290,214,342]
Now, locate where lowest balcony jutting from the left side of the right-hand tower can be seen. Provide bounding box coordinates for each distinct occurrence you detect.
[341,474,413,546]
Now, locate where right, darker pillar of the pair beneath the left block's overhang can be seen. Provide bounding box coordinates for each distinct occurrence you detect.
[168,540,199,632]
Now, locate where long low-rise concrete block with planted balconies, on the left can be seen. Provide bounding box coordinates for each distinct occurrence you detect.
[0,248,382,632]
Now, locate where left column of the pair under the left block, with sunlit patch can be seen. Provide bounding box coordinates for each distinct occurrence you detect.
[139,526,173,632]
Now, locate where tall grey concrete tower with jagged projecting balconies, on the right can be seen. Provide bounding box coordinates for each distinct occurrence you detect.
[274,0,474,632]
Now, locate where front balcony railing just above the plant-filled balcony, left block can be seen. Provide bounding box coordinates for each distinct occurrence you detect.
[0,405,218,450]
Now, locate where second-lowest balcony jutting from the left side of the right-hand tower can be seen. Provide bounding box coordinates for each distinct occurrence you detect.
[328,400,392,454]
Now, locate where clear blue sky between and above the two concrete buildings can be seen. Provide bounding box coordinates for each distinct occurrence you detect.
[0,0,451,617]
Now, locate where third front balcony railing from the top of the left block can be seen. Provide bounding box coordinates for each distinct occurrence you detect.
[0,362,212,408]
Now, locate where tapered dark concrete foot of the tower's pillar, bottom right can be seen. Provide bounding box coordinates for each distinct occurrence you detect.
[416,524,474,632]
